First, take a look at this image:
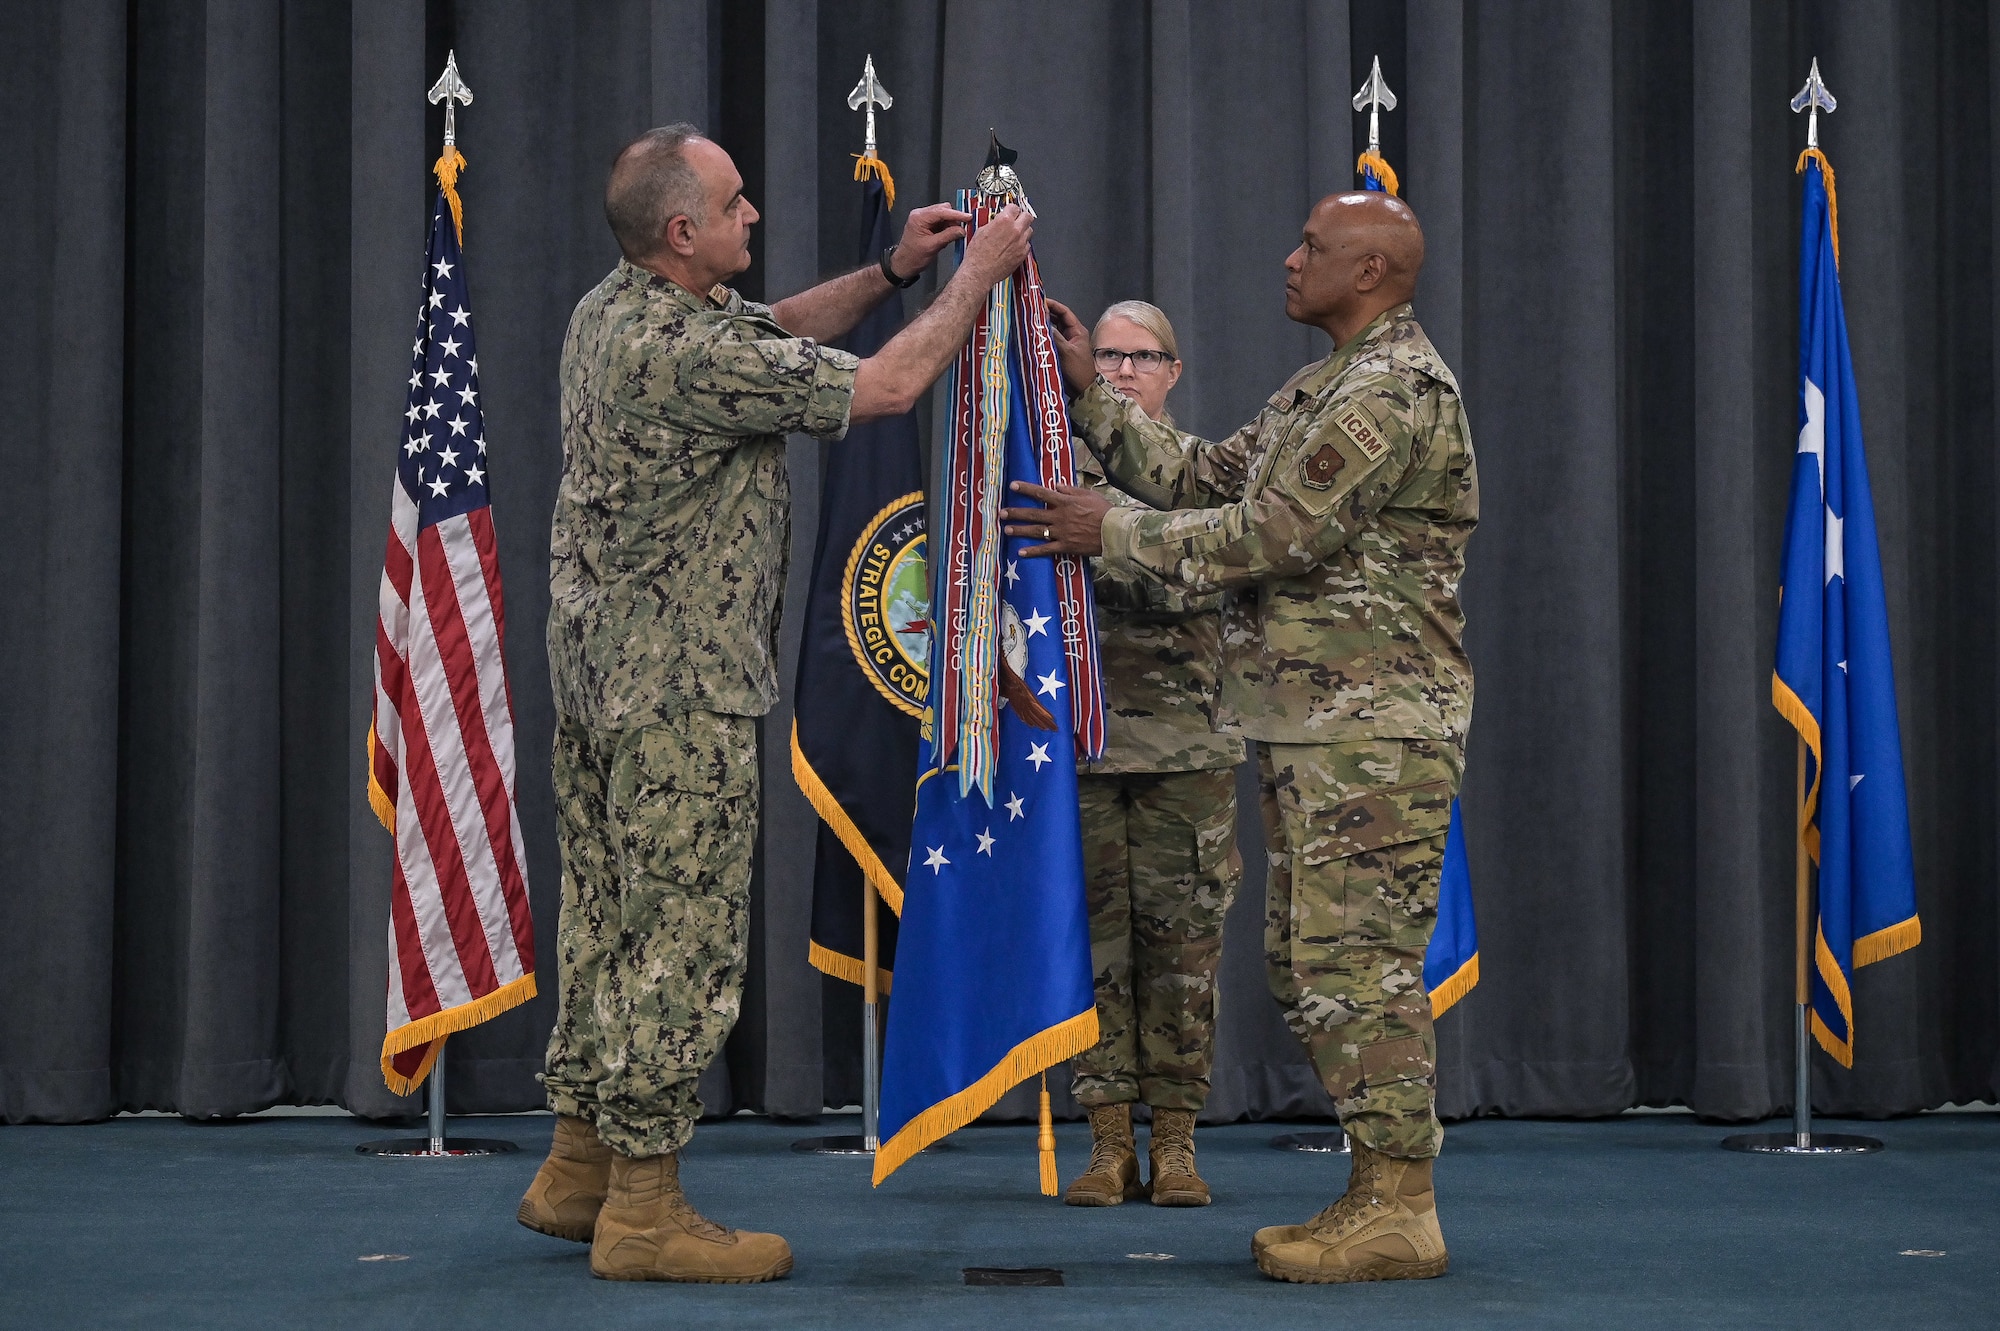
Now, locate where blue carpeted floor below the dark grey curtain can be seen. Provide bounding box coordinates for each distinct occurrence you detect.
[0,1113,2000,1331]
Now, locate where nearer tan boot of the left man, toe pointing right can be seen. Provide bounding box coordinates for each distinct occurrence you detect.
[590,1153,792,1285]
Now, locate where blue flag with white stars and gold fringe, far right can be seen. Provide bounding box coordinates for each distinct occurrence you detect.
[1772,148,1922,1067]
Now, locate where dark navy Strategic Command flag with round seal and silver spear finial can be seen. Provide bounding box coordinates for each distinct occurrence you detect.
[792,56,930,1155]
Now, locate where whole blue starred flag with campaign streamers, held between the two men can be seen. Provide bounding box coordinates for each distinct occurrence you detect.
[874,138,1104,1197]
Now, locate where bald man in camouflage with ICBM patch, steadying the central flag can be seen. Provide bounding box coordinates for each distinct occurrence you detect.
[1006,194,1478,1283]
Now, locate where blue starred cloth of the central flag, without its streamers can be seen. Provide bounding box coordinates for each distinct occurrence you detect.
[874,358,1098,1183]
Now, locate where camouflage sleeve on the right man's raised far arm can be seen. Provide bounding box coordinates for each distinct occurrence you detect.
[1070,378,1262,512]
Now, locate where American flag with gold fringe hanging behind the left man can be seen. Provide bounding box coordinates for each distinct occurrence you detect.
[368,175,534,1095]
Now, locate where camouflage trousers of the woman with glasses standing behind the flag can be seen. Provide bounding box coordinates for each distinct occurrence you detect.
[1070,767,1242,1109]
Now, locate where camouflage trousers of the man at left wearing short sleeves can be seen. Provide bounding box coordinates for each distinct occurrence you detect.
[542,711,758,1155]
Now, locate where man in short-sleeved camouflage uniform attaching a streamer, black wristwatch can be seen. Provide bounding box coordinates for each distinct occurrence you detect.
[518,126,1030,1283]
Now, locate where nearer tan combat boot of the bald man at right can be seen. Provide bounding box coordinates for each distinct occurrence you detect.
[1250,1141,1450,1285]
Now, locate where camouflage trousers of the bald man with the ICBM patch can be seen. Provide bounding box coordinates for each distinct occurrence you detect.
[1258,739,1464,1157]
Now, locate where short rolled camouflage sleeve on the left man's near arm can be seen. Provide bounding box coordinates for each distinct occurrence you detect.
[618,318,862,450]
